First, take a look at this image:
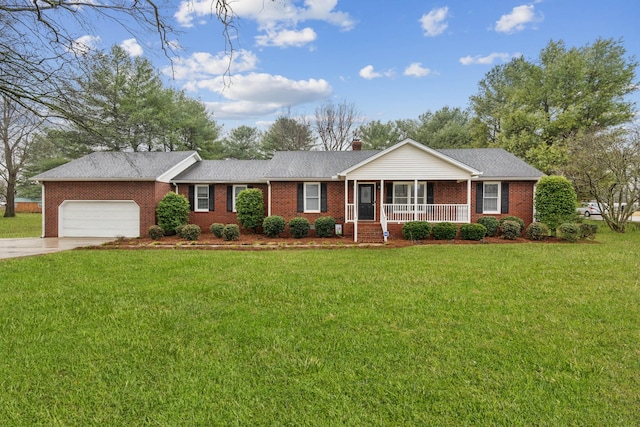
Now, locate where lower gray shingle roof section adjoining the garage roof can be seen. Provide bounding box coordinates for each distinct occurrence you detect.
[172,160,269,183]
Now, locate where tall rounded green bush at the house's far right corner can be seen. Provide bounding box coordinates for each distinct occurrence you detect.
[534,175,576,234]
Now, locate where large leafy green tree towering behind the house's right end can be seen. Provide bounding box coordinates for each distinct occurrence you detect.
[471,39,638,173]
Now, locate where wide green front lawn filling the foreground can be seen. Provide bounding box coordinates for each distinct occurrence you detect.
[0,226,640,426]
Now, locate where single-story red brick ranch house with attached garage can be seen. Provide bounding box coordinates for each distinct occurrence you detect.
[33,139,543,241]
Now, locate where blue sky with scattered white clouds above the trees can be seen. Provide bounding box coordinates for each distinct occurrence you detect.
[76,0,640,131]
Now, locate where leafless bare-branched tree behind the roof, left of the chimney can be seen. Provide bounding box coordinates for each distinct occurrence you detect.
[316,101,358,151]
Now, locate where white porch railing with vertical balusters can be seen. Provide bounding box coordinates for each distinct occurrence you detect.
[346,203,470,222]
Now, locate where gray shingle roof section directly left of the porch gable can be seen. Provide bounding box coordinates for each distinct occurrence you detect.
[266,150,378,179]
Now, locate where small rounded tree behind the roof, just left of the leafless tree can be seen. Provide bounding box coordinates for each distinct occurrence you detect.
[260,113,315,158]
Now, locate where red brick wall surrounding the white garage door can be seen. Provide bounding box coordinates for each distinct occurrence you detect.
[43,181,171,237]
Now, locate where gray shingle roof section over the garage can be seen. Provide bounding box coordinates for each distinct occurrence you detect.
[32,151,195,181]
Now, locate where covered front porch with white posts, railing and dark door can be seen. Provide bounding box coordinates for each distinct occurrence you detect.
[345,178,471,242]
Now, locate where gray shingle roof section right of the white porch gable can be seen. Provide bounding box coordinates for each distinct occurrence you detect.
[437,148,544,179]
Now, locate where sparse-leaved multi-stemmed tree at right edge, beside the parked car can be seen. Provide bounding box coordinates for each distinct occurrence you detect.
[566,126,640,232]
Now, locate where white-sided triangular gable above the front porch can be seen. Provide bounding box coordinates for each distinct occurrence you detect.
[345,143,474,180]
